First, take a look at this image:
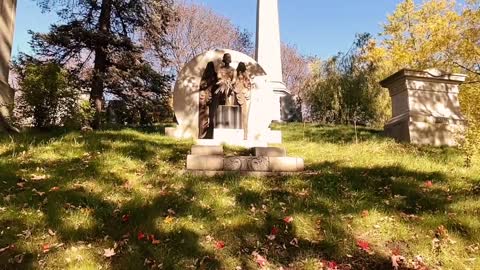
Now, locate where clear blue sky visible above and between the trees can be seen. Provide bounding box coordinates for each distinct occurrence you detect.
[13,0,400,58]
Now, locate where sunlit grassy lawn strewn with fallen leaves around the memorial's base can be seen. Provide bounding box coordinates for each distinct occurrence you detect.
[0,124,480,269]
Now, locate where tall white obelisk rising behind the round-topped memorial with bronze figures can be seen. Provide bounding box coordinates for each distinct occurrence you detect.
[255,0,289,121]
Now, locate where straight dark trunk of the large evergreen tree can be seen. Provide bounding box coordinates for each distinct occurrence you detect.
[90,0,112,129]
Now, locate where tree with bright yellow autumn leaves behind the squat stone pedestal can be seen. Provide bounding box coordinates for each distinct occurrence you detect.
[365,0,480,165]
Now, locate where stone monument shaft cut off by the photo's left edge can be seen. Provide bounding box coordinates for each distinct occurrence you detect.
[0,0,17,130]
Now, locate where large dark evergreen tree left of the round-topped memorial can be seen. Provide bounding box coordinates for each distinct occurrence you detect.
[31,0,175,128]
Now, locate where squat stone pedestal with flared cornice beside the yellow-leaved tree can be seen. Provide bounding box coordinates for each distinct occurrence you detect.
[381,69,466,146]
